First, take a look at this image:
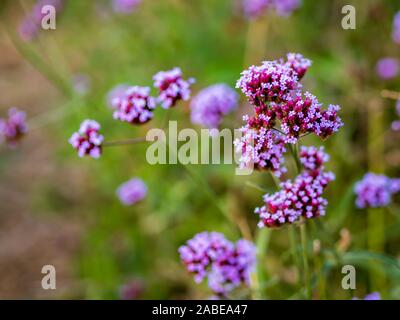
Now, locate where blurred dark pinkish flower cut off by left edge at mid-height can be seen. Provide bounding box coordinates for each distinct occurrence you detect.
[0,108,28,146]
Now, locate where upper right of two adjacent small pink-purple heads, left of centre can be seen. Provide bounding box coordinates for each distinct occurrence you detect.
[153,68,194,109]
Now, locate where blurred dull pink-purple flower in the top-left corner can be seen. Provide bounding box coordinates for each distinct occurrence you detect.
[19,0,64,41]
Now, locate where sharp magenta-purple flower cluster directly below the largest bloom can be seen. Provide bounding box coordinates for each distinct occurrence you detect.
[255,147,335,228]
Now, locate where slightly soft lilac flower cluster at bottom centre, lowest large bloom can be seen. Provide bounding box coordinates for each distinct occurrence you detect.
[179,232,256,297]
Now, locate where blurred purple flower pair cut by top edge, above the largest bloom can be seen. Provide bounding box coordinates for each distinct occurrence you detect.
[243,0,301,18]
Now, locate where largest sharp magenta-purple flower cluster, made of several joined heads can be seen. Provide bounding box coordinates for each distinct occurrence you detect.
[235,53,343,177]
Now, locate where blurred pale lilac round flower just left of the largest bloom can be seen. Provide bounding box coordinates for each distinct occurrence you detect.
[190,84,239,129]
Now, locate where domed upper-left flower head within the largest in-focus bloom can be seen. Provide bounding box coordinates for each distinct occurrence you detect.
[236,61,301,106]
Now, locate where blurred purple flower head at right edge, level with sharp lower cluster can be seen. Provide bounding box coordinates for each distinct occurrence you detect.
[354,173,400,208]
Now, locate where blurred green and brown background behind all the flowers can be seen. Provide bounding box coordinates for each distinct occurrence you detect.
[0,0,400,299]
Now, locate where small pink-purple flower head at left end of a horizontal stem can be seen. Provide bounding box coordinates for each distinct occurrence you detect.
[69,120,104,159]
